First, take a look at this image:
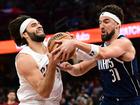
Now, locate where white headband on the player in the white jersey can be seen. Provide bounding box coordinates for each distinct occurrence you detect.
[19,18,35,37]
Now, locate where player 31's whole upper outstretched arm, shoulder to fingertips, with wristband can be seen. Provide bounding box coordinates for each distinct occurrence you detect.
[52,38,135,61]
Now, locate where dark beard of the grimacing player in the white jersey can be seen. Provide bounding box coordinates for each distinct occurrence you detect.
[27,32,46,42]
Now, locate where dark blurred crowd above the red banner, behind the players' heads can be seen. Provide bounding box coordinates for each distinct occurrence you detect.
[0,0,140,40]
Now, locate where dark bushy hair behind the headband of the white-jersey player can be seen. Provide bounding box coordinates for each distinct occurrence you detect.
[8,15,31,46]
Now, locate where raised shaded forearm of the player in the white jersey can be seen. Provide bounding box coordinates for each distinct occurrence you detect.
[38,63,56,98]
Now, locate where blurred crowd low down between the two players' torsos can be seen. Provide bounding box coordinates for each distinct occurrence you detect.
[61,70,102,105]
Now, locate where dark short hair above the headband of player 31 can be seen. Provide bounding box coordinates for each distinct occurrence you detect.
[100,4,124,23]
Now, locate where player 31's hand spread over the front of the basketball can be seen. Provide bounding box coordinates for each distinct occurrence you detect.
[52,39,76,61]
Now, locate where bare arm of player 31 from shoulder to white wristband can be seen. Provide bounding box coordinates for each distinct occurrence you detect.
[99,38,135,61]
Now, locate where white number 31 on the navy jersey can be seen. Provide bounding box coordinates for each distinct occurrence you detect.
[109,68,121,82]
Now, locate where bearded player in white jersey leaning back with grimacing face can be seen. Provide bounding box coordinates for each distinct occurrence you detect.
[9,15,63,105]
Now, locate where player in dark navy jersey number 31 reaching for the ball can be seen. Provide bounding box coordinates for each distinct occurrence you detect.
[52,5,140,105]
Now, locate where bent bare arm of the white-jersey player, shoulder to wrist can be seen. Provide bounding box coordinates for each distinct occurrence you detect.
[16,54,56,98]
